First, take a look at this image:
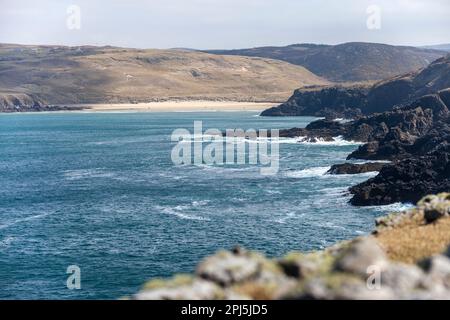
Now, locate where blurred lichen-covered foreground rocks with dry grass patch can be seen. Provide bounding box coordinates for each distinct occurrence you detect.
[132,194,450,300]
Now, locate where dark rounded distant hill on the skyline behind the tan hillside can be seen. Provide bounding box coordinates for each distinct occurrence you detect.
[206,42,446,82]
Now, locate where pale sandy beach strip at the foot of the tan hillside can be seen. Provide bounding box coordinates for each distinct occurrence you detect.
[68,101,277,112]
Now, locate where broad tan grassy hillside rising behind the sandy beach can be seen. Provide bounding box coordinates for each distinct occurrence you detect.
[0,44,329,104]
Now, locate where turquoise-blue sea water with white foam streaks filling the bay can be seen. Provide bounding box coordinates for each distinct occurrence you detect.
[0,112,406,299]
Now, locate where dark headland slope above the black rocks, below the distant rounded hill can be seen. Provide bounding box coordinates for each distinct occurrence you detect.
[262,55,450,118]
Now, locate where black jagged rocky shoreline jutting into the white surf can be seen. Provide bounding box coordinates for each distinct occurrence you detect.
[274,89,450,206]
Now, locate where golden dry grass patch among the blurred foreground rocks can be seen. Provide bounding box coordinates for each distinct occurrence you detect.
[376,214,450,263]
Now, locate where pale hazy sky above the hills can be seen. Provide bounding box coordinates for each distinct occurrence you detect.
[0,0,450,49]
